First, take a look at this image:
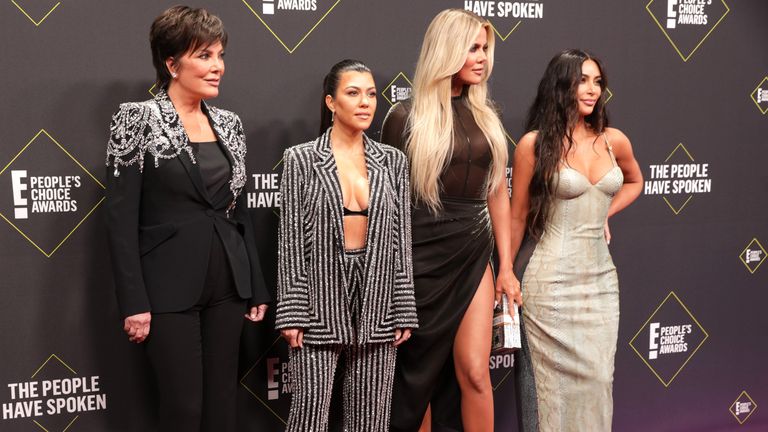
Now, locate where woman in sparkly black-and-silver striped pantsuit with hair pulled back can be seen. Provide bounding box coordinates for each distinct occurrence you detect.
[275,60,418,432]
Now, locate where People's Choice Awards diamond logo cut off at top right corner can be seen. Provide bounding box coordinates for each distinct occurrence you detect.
[645,0,730,62]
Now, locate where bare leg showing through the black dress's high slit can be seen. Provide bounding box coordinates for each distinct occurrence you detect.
[453,266,494,432]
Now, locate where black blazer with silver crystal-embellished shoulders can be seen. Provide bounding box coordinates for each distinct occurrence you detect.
[106,91,270,317]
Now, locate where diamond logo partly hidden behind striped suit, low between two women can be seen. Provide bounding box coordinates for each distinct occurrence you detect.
[240,337,291,424]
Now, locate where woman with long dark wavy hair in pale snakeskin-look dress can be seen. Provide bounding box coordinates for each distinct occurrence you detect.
[512,50,643,431]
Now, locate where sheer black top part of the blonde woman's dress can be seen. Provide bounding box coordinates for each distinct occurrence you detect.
[381,96,493,199]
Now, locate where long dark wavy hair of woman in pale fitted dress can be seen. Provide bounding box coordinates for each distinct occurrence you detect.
[525,49,608,239]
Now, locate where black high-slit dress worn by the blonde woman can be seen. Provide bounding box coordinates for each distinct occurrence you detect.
[381,96,493,431]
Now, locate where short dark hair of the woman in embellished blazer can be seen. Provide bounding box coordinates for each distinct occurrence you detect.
[149,5,227,90]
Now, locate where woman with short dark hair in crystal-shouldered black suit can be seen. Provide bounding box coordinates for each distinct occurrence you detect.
[106,6,269,432]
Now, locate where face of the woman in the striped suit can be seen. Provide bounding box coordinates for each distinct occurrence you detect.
[325,71,376,131]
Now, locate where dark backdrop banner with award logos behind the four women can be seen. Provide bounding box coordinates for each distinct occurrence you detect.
[0,0,768,432]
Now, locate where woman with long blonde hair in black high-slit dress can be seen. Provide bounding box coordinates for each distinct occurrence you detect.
[382,9,521,431]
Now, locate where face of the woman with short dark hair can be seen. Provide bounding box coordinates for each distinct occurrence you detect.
[166,42,224,99]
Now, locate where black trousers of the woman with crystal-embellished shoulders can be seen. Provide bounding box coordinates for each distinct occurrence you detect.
[146,233,246,432]
